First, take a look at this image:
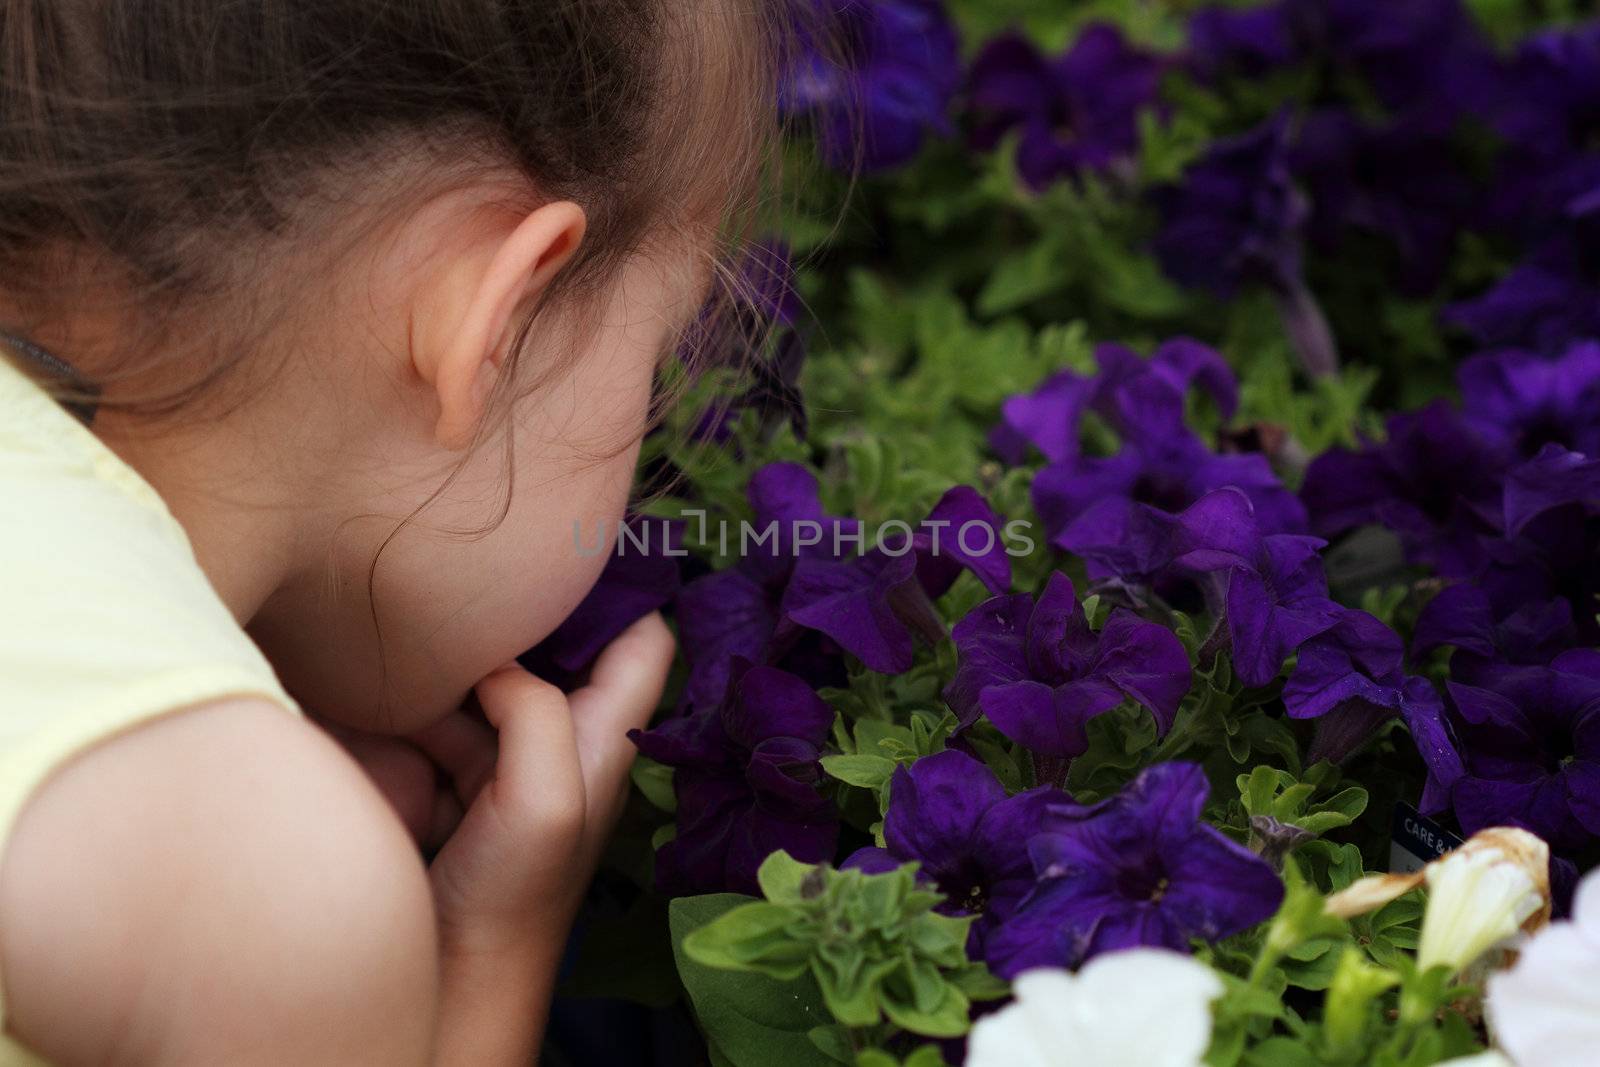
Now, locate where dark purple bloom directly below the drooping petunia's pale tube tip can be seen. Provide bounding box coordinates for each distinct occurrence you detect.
[1301,402,1502,577]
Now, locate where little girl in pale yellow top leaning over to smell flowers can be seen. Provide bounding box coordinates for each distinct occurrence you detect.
[0,0,790,1065]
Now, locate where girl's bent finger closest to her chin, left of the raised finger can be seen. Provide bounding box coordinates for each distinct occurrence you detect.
[477,661,584,819]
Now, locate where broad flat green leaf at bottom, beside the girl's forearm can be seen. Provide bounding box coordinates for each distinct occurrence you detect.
[670,893,835,1067]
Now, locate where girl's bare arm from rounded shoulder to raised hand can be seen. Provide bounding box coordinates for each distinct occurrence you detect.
[0,617,672,1064]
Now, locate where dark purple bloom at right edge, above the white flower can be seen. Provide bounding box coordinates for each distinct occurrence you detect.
[1448,649,1600,849]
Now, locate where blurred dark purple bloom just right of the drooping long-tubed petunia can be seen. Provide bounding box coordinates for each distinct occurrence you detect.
[1291,109,1475,296]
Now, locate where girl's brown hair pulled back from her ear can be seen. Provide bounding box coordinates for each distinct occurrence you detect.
[0,0,790,428]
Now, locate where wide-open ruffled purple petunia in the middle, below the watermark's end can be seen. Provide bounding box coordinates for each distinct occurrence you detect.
[944,573,1190,757]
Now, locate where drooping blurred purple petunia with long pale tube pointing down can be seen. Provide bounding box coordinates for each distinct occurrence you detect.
[1155,112,1339,376]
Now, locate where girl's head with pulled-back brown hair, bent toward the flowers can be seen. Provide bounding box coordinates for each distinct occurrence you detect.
[0,0,800,729]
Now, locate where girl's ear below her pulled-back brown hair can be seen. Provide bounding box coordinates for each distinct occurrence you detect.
[414,200,587,451]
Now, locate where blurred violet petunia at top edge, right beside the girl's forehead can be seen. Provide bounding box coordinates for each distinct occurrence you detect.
[779,0,962,171]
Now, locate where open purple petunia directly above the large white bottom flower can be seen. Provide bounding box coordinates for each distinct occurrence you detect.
[987,763,1283,977]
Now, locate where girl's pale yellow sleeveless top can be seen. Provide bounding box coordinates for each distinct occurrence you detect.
[0,352,299,1067]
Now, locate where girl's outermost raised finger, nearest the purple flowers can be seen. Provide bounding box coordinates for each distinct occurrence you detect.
[571,611,677,784]
